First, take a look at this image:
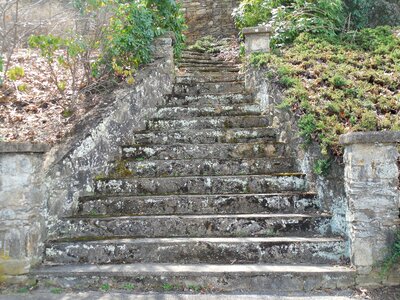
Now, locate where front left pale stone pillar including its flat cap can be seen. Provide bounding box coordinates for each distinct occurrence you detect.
[0,142,47,283]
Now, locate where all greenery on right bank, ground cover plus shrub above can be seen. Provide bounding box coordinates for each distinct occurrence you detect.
[235,0,400,157]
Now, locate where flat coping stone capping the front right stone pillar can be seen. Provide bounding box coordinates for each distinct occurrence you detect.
[339,131,400,145]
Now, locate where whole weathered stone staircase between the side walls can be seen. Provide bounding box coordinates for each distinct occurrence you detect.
[34,51,354,292]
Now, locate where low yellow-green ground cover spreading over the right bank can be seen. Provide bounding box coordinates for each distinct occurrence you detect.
[251,27,400,156]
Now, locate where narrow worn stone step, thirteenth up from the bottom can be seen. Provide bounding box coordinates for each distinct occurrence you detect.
[175,72,244,84]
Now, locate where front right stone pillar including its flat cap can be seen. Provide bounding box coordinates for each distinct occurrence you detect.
[340,132,400,285]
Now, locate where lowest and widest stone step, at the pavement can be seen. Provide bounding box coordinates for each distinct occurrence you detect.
[32,264,356,292]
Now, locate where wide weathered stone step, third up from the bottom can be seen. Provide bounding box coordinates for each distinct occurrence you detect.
[48,214,331,242]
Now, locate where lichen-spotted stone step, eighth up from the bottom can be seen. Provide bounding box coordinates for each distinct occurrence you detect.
[133,127,277,145]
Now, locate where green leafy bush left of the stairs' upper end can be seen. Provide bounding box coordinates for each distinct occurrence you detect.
[29,0,186,95]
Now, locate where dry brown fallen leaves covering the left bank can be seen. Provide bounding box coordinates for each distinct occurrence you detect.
[0,49,103,144]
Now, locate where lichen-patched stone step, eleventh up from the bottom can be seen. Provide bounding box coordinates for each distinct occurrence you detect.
[165,93,254,107]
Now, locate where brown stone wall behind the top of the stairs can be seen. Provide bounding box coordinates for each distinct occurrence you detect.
[178,0,239,44]
